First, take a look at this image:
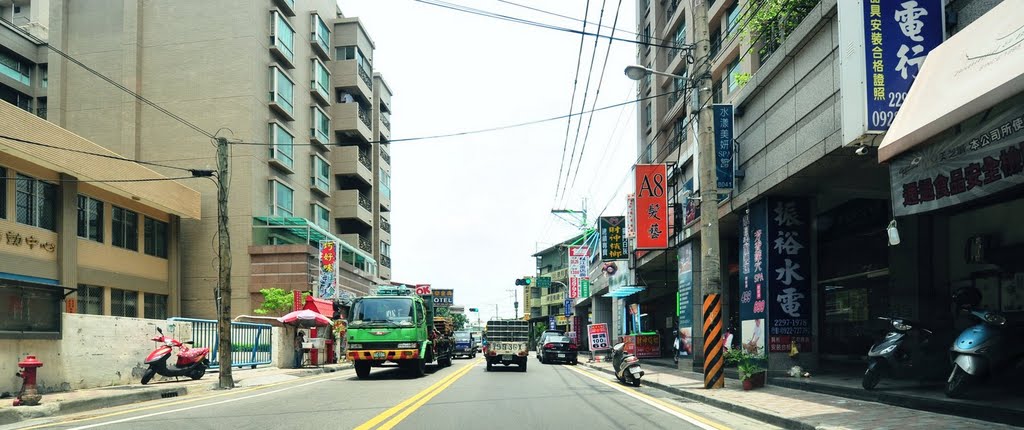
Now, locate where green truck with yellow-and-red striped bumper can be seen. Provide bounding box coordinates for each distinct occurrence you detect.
[346,286,455,379]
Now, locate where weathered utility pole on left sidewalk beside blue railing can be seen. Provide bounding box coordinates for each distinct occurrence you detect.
[216,137,234,389]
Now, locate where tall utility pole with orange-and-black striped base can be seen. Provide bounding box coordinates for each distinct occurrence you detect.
[690,1,725,388]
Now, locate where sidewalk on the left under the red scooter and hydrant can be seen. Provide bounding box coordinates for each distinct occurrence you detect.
[0,362,352,426]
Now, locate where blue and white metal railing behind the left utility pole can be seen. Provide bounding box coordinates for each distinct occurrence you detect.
[168,317,273,369]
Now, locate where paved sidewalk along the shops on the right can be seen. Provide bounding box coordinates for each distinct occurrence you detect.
[587,361,1015,430]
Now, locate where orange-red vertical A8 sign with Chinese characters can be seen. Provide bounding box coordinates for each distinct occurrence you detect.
[635,164,669,250]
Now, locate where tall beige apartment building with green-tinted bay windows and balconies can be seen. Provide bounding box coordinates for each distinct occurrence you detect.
[49,0,391,316]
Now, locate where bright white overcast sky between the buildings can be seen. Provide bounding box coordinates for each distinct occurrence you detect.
[338,0,637,320]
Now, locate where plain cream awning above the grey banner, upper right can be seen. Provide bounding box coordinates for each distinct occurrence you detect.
[879,1,1024,163]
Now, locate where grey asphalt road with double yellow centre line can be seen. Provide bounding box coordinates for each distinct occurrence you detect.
[9,358,771,430]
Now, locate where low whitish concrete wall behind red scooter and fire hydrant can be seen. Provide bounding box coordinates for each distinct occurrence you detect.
[0,313,193,393]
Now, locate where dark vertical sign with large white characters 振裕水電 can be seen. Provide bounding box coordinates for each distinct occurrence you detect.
[768,199,812,352]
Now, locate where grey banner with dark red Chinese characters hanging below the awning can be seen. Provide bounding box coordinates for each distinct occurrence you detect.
[889,104,1024,216]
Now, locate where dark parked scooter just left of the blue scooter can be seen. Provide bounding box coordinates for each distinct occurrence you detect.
[861,316,948,390]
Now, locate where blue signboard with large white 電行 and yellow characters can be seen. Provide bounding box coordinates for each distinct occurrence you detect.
[863,0,944,132]
